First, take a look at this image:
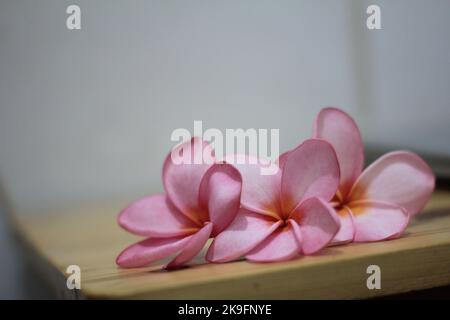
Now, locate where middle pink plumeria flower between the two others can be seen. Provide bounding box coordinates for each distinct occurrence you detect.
[206,139,339,262]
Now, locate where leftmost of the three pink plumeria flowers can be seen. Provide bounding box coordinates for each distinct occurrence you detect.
[116,137,242,269]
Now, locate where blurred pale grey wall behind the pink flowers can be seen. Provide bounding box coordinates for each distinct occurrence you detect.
[0,0,450,298]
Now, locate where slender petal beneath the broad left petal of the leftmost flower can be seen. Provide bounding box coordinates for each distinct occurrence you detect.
[116,236,191,268]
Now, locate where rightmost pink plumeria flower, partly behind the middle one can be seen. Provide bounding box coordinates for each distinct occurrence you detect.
[313,108,435,243]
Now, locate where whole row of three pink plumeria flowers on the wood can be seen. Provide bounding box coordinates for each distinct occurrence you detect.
[116,108,435,269]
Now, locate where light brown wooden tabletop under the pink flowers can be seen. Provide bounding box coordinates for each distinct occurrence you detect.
[8,191,450,299]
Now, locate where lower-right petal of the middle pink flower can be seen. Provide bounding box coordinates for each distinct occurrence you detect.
[291,198,340,255]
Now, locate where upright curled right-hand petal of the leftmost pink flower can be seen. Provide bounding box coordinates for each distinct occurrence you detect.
[200,164,242,236]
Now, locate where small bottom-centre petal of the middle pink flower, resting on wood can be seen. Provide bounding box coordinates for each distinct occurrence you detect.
[245,225,300,262]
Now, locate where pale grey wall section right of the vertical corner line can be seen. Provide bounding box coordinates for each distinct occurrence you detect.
[360,0,450,155]
